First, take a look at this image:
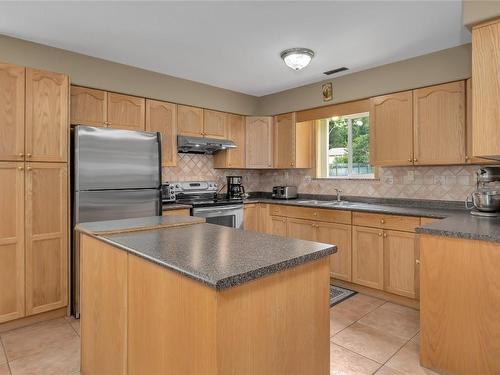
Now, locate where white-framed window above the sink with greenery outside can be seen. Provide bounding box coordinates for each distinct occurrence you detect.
[316,113,373,178]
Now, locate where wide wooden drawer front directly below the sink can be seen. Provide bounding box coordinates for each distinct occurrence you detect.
[271,205,351,224]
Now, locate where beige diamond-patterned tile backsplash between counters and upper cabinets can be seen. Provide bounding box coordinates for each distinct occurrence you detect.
[163,154,479,201]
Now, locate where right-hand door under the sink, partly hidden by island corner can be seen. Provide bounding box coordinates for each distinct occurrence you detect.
[314,222,352,281]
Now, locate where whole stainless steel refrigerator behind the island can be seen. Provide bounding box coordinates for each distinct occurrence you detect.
[72,126,161,317]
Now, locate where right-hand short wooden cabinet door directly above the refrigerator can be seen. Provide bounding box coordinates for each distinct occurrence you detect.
[108,92,146,131]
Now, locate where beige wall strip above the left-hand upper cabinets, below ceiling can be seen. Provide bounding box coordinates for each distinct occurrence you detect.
[0,35,257,114]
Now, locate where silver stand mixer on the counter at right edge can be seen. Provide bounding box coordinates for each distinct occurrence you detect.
[465,167,500,217]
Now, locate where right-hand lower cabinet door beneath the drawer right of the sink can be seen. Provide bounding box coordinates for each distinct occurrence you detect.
[383,231,417,298]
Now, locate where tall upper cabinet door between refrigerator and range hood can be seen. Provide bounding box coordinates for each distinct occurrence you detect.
[146,99,177,167]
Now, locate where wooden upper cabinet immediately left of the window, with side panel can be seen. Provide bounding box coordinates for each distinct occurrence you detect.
[273,112,313,168]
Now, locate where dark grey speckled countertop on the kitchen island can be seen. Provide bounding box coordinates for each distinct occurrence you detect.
[91,223,337,290]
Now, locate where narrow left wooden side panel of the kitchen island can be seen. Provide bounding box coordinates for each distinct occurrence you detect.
[80,235,127,375]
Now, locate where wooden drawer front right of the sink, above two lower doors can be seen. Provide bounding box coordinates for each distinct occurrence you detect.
[352,212,420,232]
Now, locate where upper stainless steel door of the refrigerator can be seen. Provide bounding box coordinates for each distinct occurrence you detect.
[73,126,161,191]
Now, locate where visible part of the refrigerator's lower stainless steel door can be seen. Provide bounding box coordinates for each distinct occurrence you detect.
[74,189,161,224]
